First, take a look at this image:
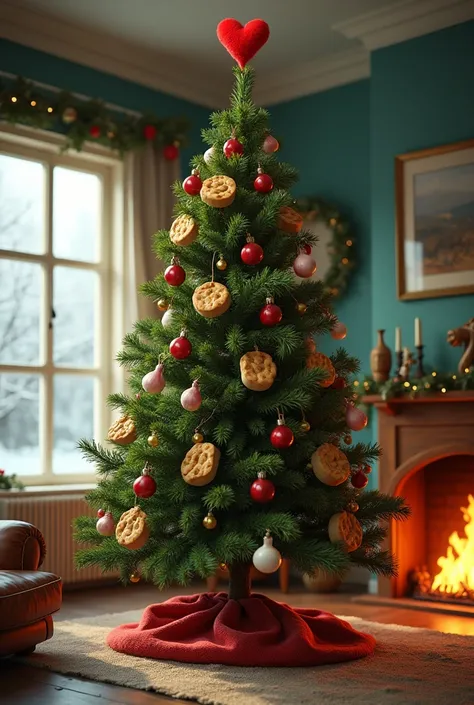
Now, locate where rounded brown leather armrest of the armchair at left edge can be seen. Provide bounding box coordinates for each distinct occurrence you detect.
[0,520,46,570]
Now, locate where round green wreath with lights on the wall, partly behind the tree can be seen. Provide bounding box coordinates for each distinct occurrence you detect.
[296,197,356,298]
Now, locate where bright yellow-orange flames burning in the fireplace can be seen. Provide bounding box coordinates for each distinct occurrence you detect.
[431,494,474,596]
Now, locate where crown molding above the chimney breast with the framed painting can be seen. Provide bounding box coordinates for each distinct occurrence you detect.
[332,0,474,51]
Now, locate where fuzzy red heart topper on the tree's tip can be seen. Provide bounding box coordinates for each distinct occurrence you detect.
[217,19,270,69]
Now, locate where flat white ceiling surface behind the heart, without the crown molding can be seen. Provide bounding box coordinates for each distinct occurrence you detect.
[11,0,388,77]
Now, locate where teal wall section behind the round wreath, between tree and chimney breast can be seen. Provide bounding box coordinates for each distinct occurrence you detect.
[270,80,373,441]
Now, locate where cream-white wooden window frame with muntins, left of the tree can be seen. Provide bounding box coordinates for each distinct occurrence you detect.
[0,124,126,487]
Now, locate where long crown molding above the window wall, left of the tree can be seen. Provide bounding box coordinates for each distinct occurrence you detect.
[0,0,228,108]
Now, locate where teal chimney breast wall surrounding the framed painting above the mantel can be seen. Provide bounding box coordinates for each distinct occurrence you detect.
[370,22,474,372]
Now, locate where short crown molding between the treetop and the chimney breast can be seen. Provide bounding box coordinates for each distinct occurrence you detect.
[254,48,370,105]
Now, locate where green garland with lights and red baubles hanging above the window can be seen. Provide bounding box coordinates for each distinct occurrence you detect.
[0,77,188,160]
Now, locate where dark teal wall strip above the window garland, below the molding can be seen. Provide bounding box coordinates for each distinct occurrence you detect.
[0,39,209,174]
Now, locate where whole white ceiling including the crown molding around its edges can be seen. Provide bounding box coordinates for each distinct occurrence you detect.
[0,0,474,107]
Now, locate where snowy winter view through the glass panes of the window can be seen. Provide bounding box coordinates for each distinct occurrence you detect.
[0,154,102,475]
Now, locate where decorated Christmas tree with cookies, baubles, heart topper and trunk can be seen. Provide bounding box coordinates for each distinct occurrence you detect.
[76,20,407,660]
